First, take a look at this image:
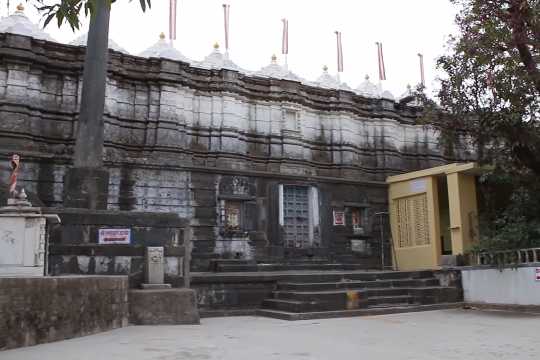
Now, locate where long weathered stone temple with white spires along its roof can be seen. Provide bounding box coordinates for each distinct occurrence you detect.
[0,10,467,274]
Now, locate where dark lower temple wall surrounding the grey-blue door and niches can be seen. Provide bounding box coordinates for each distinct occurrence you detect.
[191,172,389,271]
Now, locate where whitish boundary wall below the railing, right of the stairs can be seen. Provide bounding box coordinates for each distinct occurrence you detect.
[461,263,540,306]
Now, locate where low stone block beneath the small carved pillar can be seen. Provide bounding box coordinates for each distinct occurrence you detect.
[129,289,200,325]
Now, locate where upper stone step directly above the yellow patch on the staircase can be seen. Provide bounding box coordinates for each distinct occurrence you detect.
[277,278,439,291]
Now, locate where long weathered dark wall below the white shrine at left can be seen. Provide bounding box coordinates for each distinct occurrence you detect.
[0,276,128,348]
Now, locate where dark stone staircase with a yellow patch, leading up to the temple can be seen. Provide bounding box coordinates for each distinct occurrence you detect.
[257,271,462,320]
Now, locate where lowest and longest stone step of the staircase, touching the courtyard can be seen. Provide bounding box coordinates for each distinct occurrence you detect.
[256,302,463,321]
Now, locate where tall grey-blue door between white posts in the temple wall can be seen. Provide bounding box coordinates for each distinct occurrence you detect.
[283,185,312,249]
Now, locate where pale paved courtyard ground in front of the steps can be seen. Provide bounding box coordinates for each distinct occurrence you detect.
[0,309,540,360]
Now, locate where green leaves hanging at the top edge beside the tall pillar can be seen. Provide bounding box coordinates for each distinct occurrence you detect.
[26,0,151,30]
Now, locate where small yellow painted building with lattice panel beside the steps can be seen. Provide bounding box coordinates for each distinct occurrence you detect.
[386,163,481,270]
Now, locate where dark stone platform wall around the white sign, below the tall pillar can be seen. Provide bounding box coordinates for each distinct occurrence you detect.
[44,208,189,288]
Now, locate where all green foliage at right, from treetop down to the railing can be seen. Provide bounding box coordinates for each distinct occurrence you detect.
[418,0,540,251]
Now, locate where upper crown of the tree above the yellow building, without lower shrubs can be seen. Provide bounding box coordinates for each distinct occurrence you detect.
[426,0,540,174]
